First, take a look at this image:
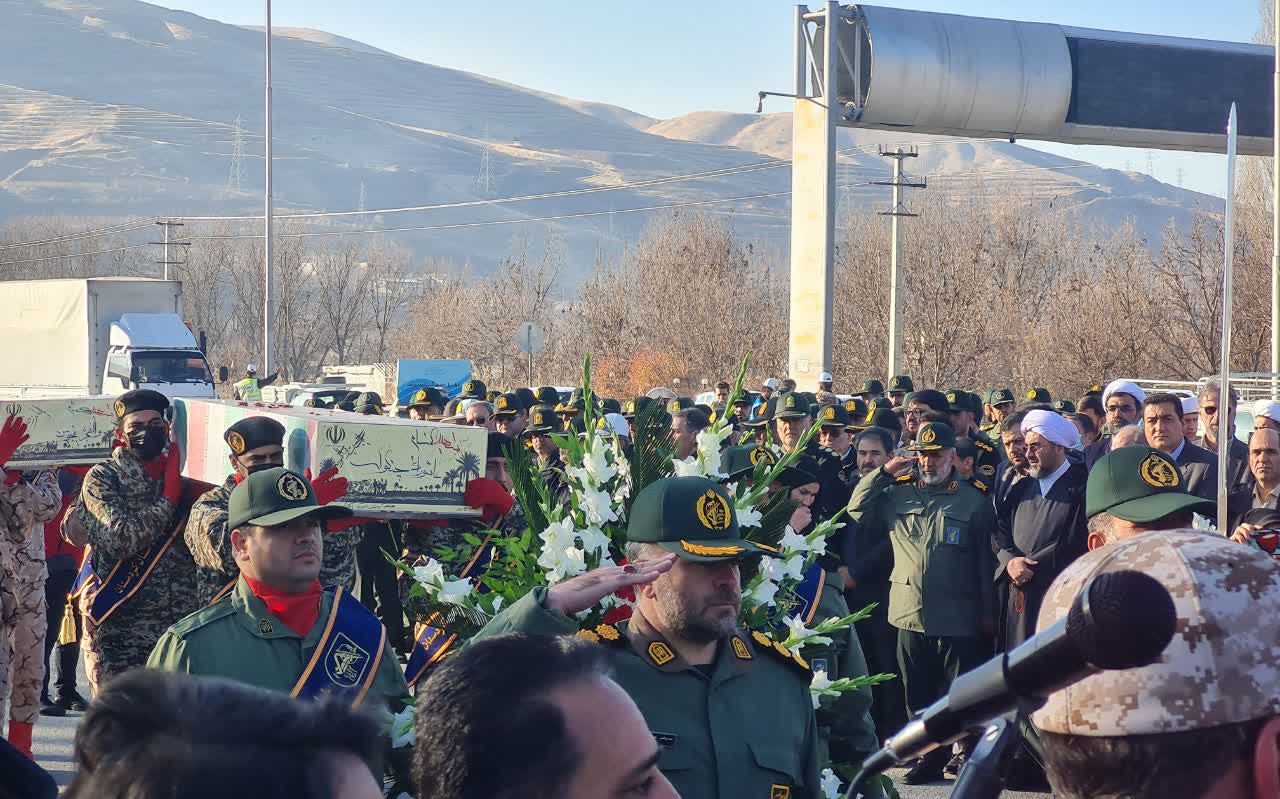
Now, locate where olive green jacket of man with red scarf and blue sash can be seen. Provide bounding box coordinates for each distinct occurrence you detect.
[147,577,408,712]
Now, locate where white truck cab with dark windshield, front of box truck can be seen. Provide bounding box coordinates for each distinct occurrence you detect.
[102,314,215,397]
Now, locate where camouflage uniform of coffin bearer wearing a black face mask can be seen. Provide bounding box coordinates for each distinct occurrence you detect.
[81,448,198,682]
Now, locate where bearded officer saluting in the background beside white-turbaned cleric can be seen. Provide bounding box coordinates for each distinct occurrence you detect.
[849,423,996,785]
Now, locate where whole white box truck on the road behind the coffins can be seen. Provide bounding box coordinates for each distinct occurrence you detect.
[0,278,214,398]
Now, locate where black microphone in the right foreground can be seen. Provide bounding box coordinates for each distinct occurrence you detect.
[850,571,1176,795]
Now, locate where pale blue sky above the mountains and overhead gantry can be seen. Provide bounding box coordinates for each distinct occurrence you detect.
[165,0,1258,195]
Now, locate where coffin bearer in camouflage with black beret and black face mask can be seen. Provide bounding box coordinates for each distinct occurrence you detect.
[64,389,197,686]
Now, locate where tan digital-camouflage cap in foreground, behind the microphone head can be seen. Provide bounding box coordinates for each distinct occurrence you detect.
[1032,530,1280,738]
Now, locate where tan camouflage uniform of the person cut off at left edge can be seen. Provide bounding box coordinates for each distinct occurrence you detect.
[0,471,63,723]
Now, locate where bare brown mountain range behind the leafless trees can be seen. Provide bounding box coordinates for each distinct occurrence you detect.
[0,0,1220,271]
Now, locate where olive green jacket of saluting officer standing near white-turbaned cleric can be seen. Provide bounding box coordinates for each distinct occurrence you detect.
[849,467,996,636]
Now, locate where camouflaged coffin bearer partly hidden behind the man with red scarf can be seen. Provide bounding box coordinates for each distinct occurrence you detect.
[183,416,355,606]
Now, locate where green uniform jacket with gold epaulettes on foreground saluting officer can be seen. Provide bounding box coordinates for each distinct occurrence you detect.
[477,589,822,799]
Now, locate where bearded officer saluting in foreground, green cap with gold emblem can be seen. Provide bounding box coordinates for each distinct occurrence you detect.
[480,478,822,799]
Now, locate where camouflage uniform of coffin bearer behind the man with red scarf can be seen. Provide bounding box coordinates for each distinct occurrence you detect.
[183,476,365,607]
